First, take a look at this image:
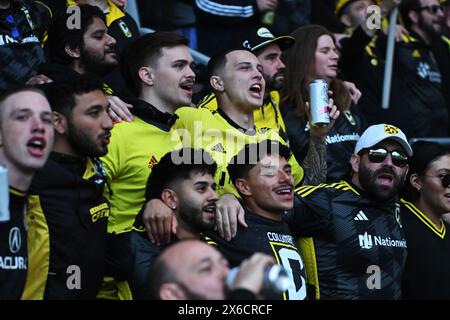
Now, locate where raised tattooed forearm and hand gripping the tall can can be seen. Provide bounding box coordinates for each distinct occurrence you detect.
[302,99,340,185]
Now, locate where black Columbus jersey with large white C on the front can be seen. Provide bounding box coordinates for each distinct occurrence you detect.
[206,209,306,300]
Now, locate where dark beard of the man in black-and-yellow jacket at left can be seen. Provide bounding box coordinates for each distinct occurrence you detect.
[67,119,108,157]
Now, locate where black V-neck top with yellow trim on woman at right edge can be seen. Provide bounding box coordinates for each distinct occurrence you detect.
[401,199,450,299]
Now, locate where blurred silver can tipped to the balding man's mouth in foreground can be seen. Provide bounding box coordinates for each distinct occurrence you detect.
[226,264,293,293]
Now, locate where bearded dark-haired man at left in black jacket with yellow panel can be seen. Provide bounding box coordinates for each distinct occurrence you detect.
[22,76,112,299]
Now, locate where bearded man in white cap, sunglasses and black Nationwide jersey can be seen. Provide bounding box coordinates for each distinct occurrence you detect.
[289,124,412,299]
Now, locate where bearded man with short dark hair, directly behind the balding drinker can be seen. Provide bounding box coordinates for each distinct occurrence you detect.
[129,148,218,300]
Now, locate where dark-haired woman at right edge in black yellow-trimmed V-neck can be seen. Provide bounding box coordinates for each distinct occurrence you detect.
[401,141,450,299]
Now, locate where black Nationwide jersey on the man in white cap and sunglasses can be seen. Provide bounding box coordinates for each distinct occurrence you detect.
[289,181,407,300]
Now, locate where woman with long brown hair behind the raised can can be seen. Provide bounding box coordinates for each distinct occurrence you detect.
[282,25,366,182]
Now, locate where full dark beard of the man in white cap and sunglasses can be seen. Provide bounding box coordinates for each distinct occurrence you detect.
[359,164,406,201]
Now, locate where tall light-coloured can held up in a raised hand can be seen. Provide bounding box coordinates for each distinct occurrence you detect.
[309,80,330,127]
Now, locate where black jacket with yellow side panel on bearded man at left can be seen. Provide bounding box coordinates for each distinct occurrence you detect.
[27,152,109,299]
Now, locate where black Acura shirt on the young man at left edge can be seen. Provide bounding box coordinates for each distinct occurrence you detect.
[0,187,27,300]
